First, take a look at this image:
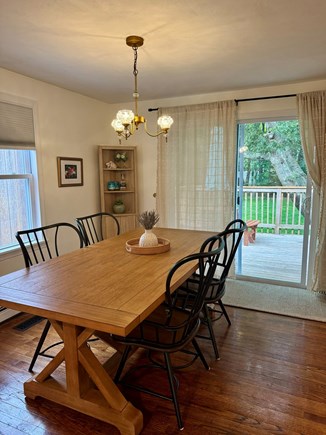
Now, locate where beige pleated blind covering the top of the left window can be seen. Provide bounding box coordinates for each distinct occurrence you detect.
[0,101,35,149]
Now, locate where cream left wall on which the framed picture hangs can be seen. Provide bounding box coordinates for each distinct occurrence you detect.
[0,69,111,275]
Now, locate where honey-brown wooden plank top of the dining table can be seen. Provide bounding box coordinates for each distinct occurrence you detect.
[0,228,213,336]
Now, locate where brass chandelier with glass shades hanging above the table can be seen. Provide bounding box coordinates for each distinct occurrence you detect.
[111,36,173,143]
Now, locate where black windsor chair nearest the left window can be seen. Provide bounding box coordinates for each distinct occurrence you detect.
[15,222,84,372]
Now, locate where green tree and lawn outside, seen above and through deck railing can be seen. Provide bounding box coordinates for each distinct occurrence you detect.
[240,120,307,234]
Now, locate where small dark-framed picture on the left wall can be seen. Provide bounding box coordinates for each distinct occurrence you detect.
[57,157,84,187]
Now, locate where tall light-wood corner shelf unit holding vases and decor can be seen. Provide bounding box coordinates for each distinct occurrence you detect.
[99,145,138,237]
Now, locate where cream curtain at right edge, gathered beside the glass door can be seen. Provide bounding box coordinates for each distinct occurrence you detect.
[297,91,326,293]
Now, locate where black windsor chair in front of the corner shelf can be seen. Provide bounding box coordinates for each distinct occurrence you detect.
[76,212,120,246]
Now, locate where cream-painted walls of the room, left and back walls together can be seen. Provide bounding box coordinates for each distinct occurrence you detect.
[0,69,326,275]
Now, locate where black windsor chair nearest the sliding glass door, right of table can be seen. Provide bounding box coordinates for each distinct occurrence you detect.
[175,219,246,359]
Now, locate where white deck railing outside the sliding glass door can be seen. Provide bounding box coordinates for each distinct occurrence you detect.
[242,186,306,234]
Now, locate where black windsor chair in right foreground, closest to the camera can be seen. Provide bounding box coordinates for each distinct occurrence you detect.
[112,236,224,430]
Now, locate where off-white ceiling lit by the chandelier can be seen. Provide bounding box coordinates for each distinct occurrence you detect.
[0,0,326,103]
